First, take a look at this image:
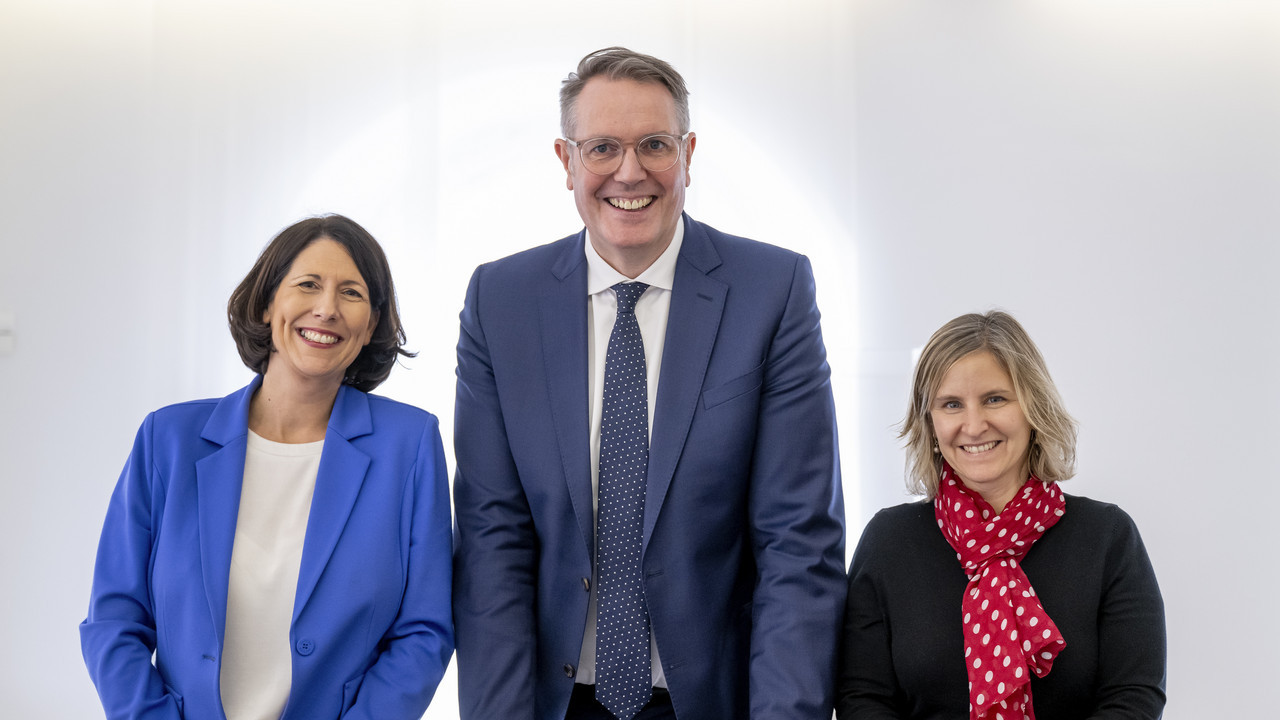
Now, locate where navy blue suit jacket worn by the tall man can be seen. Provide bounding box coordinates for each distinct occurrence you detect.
[453,215,845,720]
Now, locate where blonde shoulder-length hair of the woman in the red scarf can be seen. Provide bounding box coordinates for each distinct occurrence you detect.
[897,310,1076,500]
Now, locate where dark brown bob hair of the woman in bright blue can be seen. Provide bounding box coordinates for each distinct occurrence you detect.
[227,215,415,392]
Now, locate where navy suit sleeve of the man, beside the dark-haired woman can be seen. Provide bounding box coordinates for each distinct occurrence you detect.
[453,268,538,720]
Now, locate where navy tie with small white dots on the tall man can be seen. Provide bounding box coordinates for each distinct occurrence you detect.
[595,283,653,720]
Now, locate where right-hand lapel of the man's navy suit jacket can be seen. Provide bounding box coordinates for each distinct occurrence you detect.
[643,215,728,548]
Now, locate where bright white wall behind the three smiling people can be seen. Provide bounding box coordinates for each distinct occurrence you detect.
[0,0,1280,720]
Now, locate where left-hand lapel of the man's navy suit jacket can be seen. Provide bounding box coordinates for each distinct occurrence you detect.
[539,233,595,562]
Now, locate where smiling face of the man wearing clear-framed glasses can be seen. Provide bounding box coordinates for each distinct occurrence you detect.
[556,77,696,278]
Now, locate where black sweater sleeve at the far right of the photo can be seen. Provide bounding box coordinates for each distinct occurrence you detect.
[1089,507,1167,720]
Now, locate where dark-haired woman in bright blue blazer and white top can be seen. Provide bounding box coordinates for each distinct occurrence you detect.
[81,215,453,720]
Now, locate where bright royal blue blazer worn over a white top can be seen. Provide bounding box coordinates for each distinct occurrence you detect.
[81,379,453,720]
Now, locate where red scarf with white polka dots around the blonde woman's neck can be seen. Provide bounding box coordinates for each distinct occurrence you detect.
[933,464,1066,720]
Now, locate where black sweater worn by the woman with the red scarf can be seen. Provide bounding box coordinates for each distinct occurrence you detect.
[836,496,1165,720]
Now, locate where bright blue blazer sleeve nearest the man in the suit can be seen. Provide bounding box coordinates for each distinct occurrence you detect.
[343,418,453,720]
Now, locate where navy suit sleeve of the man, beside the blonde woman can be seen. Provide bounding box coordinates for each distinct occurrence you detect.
[749,258,846,720]
